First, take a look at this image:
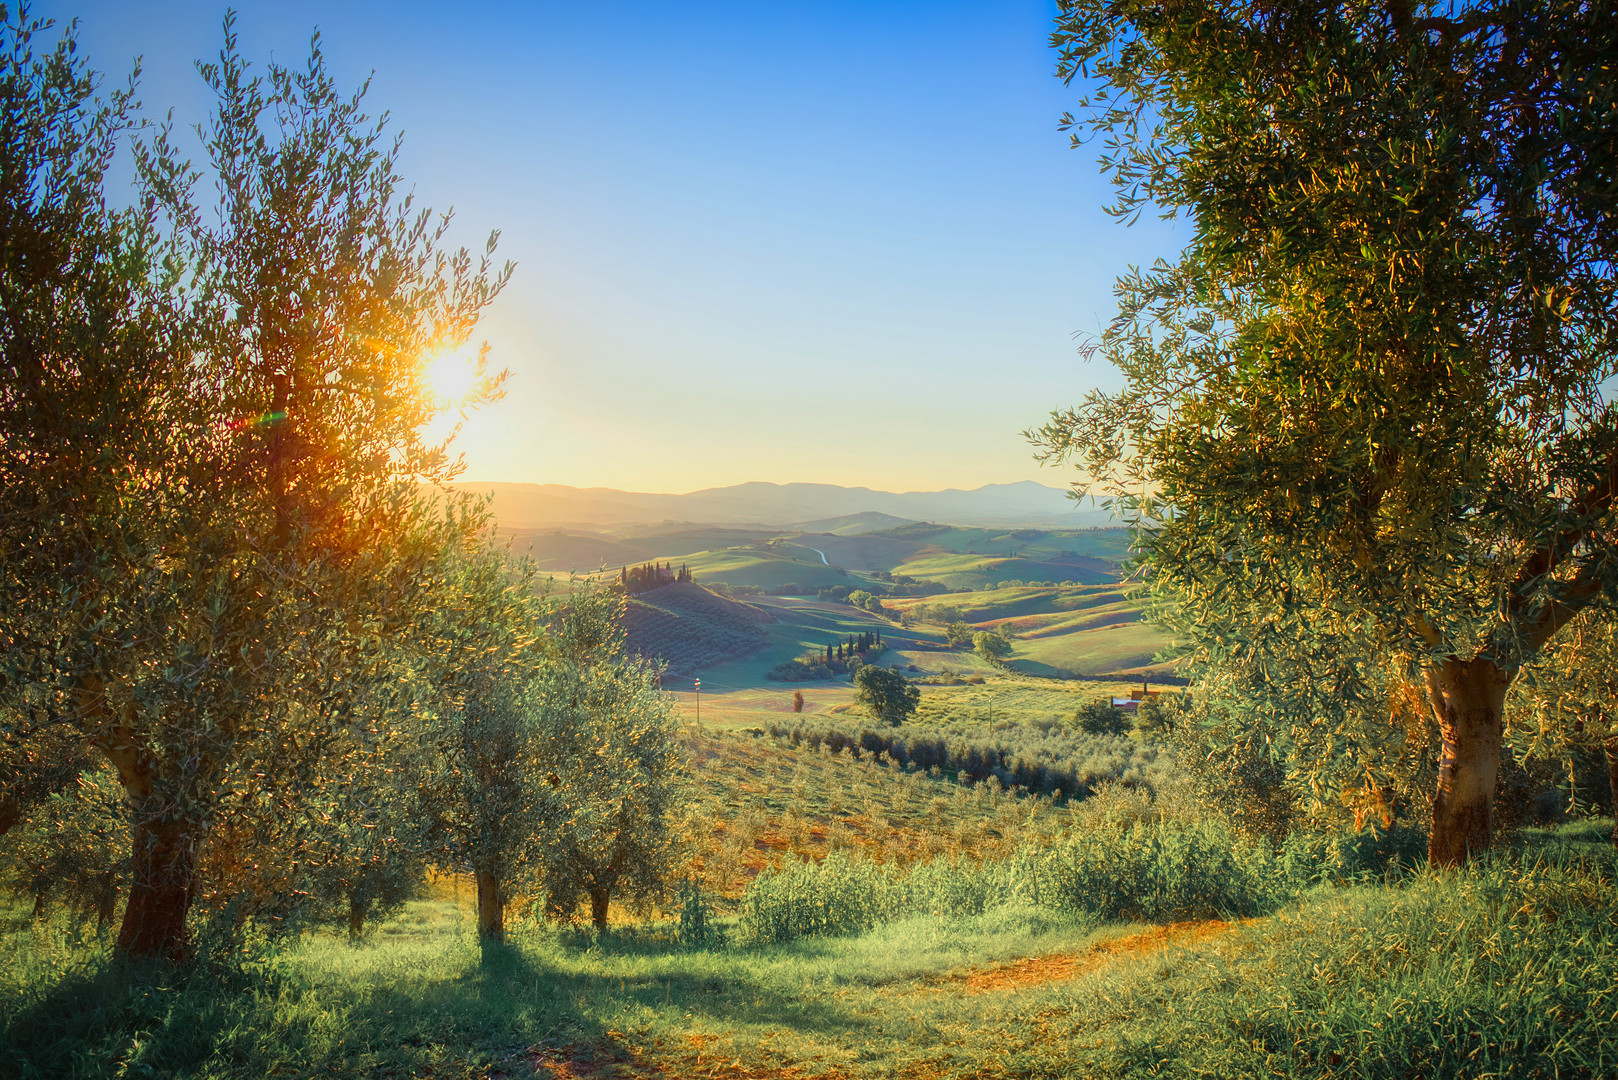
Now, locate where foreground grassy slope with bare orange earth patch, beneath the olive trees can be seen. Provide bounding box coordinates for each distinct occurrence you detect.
[0,822,1618,1080]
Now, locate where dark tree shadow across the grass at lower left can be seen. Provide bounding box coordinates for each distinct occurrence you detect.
[0,939,867,1080]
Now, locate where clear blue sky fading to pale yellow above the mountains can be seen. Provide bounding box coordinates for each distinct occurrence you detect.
[32,0,1178,492]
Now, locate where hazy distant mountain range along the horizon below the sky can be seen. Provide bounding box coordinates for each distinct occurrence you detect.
[455,481,1112,531]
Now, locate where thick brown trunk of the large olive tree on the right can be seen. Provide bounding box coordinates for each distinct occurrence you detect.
[1427,657,1511,866]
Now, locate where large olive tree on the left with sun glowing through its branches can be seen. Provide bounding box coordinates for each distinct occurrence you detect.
[0,13,505,959]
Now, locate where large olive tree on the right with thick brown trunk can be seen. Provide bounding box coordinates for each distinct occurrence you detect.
[1034,0,1618,865]
